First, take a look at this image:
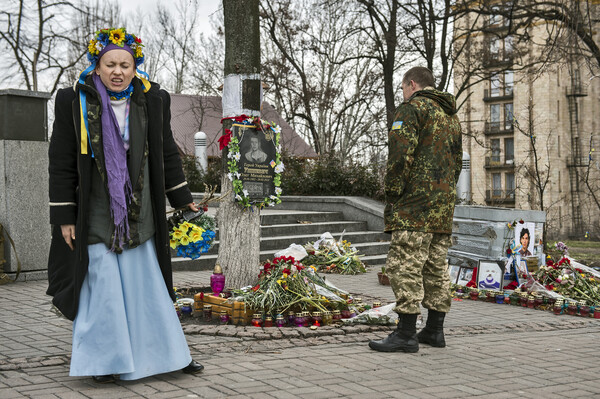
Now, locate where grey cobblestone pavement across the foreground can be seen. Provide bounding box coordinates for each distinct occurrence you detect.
[0,270,600,399]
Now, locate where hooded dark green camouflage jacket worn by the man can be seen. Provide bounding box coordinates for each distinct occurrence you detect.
[384,89,462,234]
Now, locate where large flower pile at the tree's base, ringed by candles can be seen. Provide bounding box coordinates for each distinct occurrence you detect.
[234,256,348,315]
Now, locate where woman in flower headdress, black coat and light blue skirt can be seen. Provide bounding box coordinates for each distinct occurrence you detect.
[47,28,203,382]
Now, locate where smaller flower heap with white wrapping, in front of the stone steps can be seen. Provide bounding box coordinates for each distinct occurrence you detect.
[302,237,367,274]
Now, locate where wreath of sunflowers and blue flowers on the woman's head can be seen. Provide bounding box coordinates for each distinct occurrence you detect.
[87,28,144,66]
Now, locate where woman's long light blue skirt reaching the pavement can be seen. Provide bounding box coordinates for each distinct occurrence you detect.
[70,239,192,380]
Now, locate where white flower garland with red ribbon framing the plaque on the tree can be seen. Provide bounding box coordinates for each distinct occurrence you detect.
[219,115,284,209]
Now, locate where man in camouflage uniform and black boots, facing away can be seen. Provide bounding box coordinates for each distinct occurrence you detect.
[369,67,462,352]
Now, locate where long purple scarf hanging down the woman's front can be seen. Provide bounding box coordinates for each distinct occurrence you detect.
[93,73,133,251]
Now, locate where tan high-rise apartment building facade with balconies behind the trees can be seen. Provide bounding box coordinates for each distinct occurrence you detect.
[455,3,600,239]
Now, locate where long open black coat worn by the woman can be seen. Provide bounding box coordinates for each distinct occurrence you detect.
[46,78,192,320]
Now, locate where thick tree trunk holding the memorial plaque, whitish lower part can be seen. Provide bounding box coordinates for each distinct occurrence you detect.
[217,0,260,288]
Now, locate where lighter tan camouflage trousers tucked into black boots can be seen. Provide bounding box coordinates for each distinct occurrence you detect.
[386,230,452,314]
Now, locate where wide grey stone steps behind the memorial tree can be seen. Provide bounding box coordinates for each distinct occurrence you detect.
[171,210,390,271]
